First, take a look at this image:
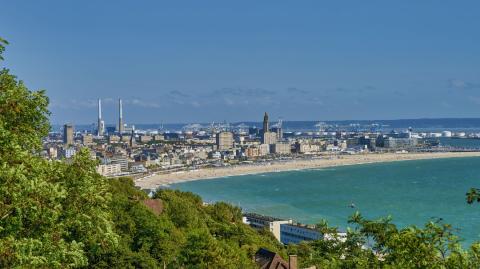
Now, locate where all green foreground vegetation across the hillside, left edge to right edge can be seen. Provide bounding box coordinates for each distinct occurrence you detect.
[0,39,480,268]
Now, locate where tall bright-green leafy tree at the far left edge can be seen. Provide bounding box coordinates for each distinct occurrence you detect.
[0,39,116,268]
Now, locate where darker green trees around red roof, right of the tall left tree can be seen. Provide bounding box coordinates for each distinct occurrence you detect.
[90,178,282,268]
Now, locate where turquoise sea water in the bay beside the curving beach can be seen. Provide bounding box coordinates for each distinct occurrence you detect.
[172,158,480,244]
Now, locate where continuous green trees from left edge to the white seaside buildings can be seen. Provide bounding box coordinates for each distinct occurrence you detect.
[0,39,281,268]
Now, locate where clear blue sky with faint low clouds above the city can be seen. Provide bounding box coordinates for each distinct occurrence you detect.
[0,0,480,124]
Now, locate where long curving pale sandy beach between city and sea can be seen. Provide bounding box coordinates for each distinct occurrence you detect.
[135,152,480,189]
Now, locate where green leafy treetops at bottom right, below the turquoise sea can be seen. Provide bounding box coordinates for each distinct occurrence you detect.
[288,213,480,268]
